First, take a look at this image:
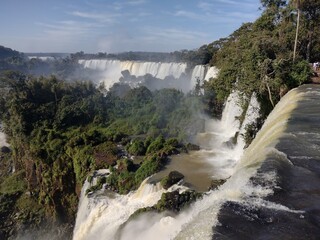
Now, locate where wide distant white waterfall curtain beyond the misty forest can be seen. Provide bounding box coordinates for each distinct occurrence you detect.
[79,59,218,91]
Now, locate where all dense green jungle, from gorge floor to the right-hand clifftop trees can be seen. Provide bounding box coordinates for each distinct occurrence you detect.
[0,0,320,239]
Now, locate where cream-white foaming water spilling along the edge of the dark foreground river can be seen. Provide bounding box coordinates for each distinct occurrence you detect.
[120,88,301,240]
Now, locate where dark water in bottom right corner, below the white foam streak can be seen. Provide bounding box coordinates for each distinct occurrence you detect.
[212,202,320,240]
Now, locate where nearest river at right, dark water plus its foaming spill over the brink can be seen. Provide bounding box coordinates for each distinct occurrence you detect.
[74,85,320,240]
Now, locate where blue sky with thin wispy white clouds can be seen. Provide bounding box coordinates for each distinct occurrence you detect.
[0,0,261,53]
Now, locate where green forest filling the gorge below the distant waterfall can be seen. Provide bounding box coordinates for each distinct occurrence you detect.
[0,72,205,225]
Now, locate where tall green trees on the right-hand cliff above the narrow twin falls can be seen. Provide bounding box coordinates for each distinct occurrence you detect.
[205,0,320,117]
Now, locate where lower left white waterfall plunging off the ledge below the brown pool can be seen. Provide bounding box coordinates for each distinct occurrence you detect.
[73,172,190,240]
